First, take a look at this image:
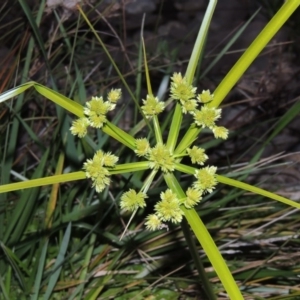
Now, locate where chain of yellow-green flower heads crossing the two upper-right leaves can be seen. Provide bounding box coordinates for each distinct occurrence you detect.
[171,73,228,139]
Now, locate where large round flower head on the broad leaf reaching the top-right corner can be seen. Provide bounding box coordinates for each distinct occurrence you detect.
[194,105,222,129]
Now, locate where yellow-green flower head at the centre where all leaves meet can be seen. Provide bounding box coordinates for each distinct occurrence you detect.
[149,143,174,172]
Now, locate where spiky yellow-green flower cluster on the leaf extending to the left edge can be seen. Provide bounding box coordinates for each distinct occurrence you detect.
[83,150,119,192]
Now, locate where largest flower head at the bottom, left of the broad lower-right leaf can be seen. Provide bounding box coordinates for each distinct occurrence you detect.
[154,189,183,224]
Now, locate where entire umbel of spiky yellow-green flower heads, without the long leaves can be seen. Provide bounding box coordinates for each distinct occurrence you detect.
[70,73,228,230]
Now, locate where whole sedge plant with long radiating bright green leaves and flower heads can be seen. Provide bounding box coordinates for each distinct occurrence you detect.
[0,0,300,300]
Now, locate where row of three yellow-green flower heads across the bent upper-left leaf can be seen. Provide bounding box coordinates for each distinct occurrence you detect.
[70,89,121,138]
